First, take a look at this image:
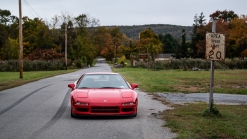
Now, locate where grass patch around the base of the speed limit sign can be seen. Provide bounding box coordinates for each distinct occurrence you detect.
[164,104,247,139]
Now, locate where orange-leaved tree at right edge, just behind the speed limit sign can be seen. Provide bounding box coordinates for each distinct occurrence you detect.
[207,10,247,59]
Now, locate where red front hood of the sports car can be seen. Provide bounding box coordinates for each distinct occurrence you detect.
[76,89,134,103]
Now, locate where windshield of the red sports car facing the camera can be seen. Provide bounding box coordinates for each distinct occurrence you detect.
[78,74,129,89]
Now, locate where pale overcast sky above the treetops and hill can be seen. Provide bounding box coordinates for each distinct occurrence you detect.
[0,0,247,26]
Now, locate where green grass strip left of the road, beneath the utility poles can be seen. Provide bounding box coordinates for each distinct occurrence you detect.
[0,69,77,91]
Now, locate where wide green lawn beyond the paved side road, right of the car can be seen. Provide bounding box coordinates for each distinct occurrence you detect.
[113,68,247,94]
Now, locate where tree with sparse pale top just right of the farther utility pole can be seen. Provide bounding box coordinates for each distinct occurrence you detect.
[68,14,100,65]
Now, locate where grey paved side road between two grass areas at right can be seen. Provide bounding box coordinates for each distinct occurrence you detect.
[158,93,247,105]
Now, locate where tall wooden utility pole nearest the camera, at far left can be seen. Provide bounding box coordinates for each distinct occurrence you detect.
[19,0,23,79]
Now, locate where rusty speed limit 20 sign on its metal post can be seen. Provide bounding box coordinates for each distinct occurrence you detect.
[205,20,225,112]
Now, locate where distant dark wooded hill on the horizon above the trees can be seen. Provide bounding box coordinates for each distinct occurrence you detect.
[102,24,193,40]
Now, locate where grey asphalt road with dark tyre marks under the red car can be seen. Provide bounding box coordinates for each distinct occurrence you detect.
[0,61,176,139]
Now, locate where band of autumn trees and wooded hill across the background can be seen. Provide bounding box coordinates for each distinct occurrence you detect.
[0,9,247,71]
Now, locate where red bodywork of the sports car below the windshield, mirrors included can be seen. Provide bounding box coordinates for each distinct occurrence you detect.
[68,73,138,117]
